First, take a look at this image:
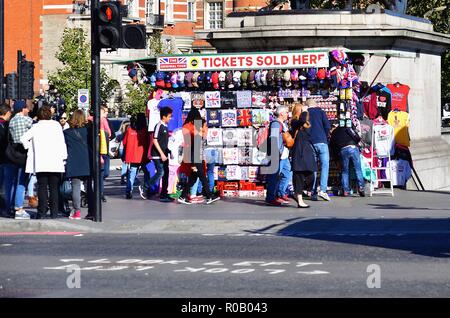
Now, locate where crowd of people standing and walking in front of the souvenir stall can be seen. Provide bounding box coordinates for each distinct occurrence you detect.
[0,93,365,219]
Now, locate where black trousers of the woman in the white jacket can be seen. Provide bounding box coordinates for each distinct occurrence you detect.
[36,172,61,218]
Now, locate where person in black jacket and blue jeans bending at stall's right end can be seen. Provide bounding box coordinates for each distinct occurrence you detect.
[330,127,365,197]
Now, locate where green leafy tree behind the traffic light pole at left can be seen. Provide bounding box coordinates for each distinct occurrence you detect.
[48,28,118,112]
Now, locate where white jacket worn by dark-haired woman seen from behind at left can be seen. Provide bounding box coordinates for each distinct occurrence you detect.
[20,120,67,173]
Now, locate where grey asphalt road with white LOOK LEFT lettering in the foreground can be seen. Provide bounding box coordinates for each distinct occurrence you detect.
[0,233,450,298]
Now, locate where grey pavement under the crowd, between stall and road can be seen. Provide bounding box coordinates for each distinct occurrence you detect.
[0,164,450,235]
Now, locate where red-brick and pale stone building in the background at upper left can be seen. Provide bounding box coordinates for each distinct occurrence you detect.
[5,0,266,91]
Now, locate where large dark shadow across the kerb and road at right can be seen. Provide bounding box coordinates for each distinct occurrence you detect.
[251,218,450,258]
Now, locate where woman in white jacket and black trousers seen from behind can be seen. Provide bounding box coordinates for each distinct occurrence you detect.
[20,106,67,219]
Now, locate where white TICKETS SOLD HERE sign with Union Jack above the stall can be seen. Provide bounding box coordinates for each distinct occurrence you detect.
[157,51,329,71]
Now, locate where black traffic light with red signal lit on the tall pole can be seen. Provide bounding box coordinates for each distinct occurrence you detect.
[94,1,122,49]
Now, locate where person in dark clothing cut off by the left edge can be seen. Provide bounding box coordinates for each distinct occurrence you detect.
[0,105,11,217]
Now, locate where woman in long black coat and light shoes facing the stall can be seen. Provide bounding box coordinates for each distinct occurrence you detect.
[291,104,317,208]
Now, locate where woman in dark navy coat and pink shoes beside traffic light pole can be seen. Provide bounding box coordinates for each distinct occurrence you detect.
[64,109,91,220]
